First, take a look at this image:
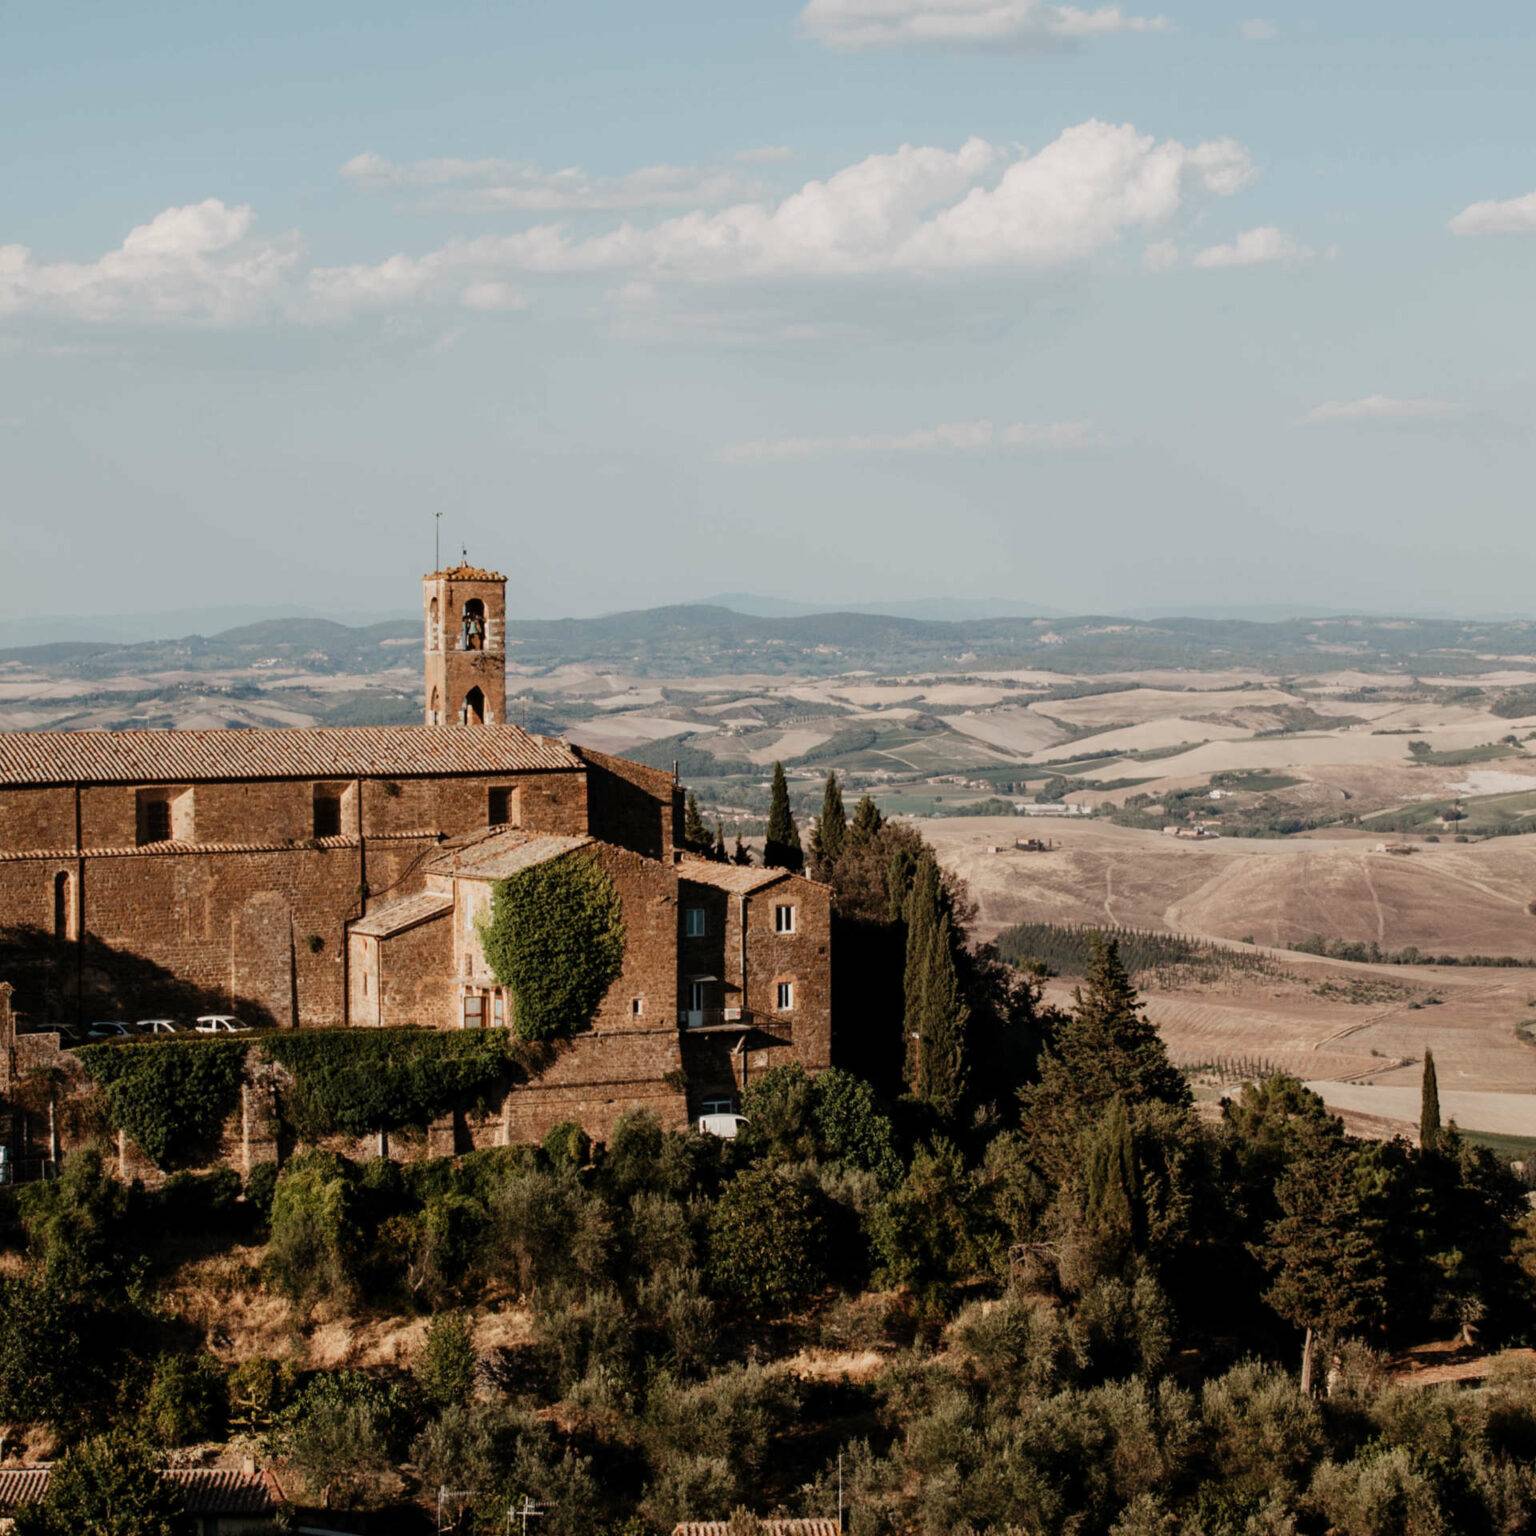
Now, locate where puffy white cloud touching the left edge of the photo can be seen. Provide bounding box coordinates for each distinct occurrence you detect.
[0,198,303,324]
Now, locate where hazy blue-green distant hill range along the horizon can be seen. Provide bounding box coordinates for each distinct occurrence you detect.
[12,604,1536,679]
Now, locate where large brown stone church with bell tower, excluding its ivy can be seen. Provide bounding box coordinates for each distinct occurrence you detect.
[0,565,831,1138]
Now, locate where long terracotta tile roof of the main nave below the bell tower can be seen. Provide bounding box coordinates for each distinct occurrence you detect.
[0,725,581,785]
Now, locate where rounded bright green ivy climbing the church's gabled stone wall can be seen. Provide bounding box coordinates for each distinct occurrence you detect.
[481,854,624,1040]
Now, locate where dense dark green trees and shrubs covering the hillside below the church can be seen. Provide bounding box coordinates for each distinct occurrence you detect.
[0,798,1536,1536]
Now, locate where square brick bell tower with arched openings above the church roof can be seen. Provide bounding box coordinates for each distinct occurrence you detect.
[421,559,507,725]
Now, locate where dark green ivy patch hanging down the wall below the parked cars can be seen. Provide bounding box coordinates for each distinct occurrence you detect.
[75,1040,246,1169]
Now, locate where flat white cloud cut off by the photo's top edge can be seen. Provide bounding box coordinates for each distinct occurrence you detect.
[800,0,1169,49]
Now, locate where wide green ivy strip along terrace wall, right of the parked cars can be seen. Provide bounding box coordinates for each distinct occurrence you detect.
[261,1029,530,1141]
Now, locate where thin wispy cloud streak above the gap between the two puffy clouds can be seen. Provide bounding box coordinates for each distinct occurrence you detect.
[341,154,750,214]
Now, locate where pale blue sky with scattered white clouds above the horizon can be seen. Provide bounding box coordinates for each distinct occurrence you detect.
[0,0,1536,619]
